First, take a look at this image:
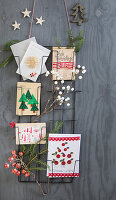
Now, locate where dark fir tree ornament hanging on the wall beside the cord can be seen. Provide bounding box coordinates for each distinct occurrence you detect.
[71,3,88,26]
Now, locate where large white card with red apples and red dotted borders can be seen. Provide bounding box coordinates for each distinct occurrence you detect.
[47,134,81,178]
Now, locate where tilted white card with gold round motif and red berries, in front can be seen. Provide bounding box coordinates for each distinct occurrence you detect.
[20,42,50,82]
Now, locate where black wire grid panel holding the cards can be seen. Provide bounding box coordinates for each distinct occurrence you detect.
[16,47,81,183]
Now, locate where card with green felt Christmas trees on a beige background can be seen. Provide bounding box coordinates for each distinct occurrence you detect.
[16,82,41,115]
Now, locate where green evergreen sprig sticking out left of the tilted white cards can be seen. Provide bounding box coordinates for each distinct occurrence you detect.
[0,40,20,68]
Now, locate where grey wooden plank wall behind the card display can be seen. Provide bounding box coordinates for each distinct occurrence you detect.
[0,0,116,200]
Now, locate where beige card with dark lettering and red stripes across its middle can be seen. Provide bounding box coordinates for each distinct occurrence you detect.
[52,47,76,80]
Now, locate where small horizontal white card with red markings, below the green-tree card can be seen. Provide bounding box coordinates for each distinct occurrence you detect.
[15,123,46,144]
